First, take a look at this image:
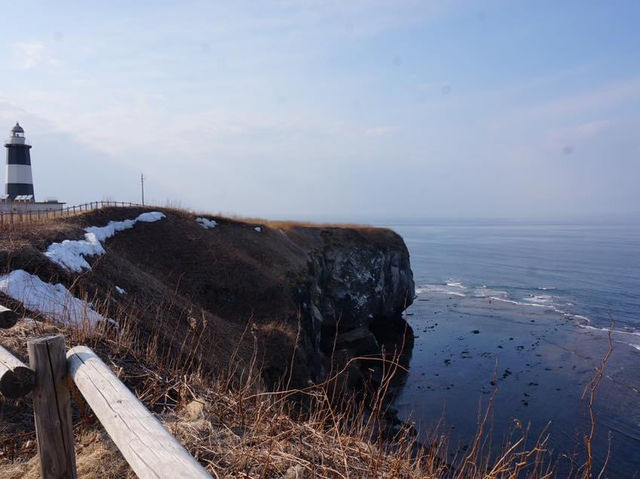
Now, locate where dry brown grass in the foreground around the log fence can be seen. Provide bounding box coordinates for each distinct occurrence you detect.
[0,304,564,478]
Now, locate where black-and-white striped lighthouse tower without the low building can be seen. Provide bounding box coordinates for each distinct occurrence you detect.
[3,123,35,202]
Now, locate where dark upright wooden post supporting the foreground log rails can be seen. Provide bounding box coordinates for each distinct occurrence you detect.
[28,335,77,479]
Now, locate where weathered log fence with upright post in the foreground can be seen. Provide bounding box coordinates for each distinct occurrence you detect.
[0,308,211,479]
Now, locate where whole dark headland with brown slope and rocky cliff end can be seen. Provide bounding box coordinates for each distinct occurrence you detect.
[0,208,414,390]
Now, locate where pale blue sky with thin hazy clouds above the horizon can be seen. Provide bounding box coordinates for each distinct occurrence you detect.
[0,0,640,221]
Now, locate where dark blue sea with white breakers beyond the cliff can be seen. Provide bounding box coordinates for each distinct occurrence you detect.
[390,221,640,478]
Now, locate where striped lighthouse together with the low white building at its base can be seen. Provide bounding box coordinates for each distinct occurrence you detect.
[0,123,64,213]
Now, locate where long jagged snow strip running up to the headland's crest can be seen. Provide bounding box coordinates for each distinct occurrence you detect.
[44,211,164,273]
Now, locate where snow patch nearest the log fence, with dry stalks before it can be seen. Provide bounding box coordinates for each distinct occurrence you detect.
[0,269,117,328]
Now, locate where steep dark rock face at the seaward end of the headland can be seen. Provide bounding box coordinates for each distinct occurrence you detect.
[299,231,415,382]
